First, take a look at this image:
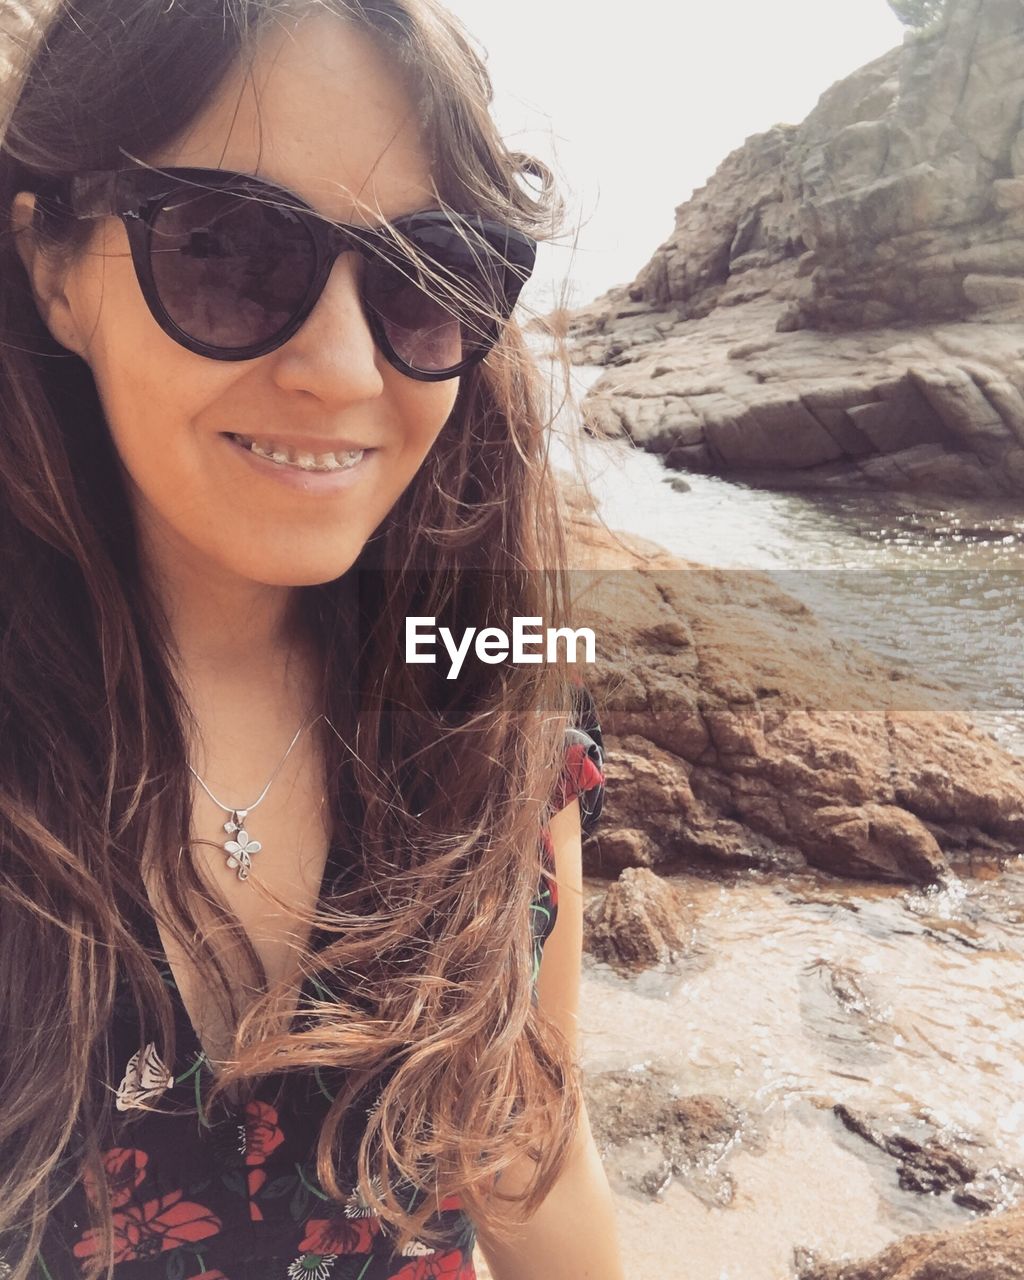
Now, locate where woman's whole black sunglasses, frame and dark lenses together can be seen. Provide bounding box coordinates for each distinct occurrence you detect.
[40,168,536,381]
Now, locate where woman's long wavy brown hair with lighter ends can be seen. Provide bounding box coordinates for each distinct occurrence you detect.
[0,0,581,1280]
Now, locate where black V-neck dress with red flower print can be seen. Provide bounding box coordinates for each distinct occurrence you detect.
[32,686,604,1280]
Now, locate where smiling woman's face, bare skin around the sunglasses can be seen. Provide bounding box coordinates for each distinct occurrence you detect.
[15,15,458,586]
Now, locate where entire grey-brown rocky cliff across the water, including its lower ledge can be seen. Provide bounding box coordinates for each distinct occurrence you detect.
[571,0,1024,495]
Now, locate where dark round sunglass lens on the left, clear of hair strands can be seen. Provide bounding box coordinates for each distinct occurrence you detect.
[150,189,316,351]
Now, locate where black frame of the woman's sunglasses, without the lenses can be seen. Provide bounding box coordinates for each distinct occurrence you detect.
[44,166,536,383]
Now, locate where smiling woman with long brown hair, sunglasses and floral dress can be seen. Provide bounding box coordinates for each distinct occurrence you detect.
[0,0,621,1280]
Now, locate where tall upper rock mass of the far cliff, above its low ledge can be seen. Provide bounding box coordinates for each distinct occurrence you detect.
[630,0,1024,326]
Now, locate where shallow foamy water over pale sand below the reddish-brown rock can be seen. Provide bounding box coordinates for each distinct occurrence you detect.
[584,869,1024,1280]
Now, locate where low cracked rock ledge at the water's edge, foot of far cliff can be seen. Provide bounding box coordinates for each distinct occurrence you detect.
[570,300,1024,498]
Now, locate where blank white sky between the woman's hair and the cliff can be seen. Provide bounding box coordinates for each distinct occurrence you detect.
[445,0,904,310]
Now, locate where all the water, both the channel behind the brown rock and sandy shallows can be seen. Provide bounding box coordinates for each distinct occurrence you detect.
[535,353,1024,1280]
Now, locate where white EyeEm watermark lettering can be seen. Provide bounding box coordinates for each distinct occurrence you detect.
[406,618,596,680]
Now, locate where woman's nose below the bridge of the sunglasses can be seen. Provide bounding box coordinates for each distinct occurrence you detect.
[267,251,384,402]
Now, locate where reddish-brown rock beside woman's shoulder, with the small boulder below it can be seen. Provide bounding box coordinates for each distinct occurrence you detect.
[560,494,1024,885]
